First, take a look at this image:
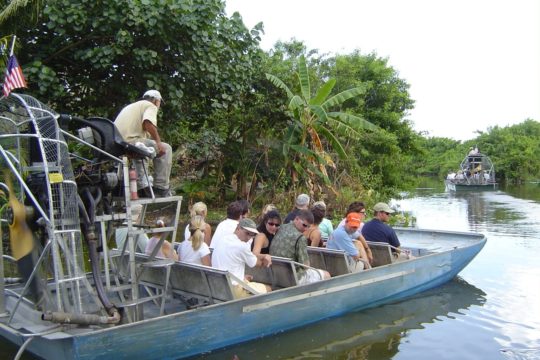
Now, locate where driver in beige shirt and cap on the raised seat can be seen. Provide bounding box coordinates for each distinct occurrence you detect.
[114,90,172,197]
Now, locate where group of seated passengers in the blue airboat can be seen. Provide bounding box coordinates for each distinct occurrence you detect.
[141,194,409,298]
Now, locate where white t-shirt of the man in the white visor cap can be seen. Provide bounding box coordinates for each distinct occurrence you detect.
[212,234,257,285]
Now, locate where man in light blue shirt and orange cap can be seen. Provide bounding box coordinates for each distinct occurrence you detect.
[326,212,371,272]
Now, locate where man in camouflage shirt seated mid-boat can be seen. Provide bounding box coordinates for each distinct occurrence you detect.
[270,210,330,285]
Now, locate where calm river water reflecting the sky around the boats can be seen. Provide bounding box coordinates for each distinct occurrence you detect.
[0,182,540,360]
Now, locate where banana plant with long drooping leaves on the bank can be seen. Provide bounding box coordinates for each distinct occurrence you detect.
[266,56,377,191]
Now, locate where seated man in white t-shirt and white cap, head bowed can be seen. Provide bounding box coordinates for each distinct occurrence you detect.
[212,218,272,299]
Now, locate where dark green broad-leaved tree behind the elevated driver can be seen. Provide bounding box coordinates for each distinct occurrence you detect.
[13,0,261,131]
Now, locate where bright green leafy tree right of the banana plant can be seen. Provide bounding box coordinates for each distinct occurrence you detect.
[329,50,421,196]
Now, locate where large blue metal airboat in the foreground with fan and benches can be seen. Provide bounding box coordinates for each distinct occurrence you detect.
[0,93,486,359]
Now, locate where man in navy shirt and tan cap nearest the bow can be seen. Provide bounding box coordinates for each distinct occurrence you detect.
[362,202,408,258]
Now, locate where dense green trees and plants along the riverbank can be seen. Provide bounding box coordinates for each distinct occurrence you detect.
[0,0,540,214]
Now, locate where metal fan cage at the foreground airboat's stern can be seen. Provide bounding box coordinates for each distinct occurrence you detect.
[0,94,86,313]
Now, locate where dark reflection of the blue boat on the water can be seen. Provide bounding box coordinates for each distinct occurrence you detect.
[191,277,486,360]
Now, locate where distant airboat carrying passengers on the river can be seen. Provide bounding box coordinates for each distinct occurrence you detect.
[444,148,497,191]
